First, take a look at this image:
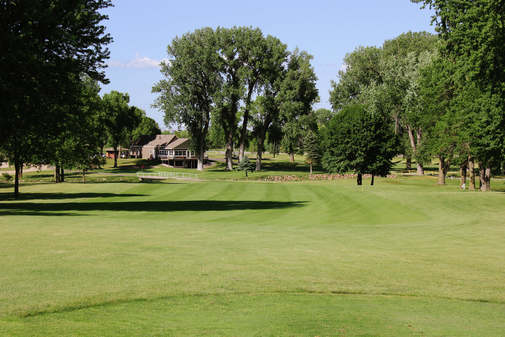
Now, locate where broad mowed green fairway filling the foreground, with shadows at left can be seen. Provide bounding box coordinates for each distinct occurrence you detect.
[0,178,505,337]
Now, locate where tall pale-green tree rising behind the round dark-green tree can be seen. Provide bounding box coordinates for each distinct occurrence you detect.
[330,32,437,175]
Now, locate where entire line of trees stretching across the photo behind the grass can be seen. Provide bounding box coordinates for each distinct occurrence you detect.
[0,0,505,196]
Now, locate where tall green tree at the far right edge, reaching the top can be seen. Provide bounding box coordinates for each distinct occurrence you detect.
[412,0,505,191]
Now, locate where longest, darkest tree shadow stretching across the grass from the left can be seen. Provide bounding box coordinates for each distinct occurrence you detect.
[0,200,306,215]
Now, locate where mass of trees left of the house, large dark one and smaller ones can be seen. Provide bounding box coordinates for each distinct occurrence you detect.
[0,0,159,197]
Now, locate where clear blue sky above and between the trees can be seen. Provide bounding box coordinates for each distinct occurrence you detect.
[102,0,434,129]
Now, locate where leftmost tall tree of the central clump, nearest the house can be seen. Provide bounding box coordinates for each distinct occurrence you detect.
[153,28,221,170]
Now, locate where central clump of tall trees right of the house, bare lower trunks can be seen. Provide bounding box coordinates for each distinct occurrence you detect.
[153,27,318,170]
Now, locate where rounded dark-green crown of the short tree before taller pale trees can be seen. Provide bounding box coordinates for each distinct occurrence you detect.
[322,105,397,181]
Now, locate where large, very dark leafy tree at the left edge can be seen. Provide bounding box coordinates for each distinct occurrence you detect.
[0,0,112,196]
